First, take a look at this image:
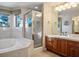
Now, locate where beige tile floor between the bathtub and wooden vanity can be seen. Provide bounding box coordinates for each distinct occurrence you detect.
[32,48,60,57]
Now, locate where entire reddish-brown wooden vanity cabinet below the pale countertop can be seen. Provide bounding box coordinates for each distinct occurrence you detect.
[45,36,79,57]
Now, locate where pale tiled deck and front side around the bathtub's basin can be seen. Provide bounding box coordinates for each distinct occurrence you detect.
[0,38,33,57]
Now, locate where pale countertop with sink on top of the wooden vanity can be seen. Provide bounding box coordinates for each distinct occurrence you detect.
[47,35,79,41]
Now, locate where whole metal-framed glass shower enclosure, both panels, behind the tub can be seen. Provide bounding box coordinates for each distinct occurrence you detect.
[24,10,42,48]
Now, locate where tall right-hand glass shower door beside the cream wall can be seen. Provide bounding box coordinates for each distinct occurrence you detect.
[33,11,42,48]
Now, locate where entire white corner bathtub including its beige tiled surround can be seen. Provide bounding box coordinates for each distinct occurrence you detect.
[0,38,33,57]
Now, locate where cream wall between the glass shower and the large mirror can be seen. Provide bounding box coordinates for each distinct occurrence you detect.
[43,3,58,47]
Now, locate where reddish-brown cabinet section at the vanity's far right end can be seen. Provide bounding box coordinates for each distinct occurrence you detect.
[68,41,79,57]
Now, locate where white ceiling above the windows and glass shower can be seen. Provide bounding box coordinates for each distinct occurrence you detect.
[0,2,43,10]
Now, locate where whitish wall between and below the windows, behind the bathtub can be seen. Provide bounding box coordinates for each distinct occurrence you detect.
[0,14,22,39]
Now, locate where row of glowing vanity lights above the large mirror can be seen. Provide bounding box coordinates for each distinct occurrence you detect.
[55,3,77,12]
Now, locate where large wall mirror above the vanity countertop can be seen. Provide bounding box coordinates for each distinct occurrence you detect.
[58,3,79,34]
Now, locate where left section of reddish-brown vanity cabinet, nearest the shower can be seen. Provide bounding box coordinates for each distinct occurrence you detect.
[45,37,67,56]
